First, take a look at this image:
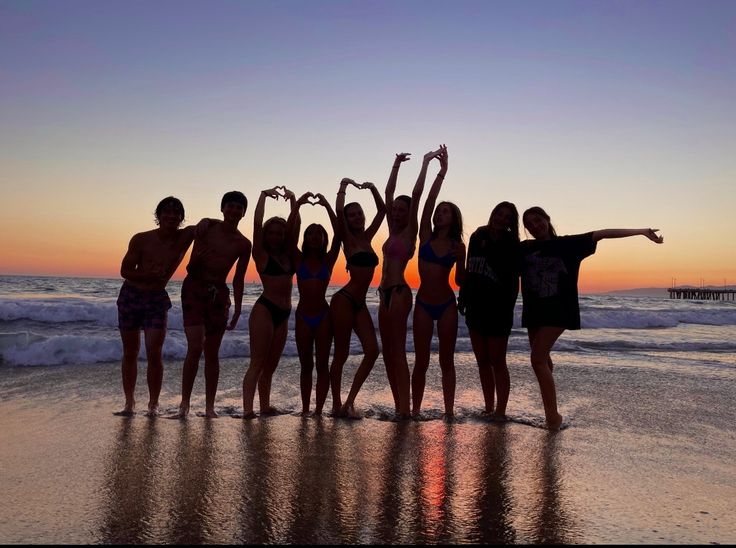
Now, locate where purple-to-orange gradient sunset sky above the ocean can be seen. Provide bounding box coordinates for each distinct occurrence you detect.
[0,0,736,292]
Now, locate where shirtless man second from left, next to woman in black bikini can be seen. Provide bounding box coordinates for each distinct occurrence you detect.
[172,191,251,419]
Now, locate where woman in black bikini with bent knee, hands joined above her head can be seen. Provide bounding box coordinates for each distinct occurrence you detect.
[330,179,386,418]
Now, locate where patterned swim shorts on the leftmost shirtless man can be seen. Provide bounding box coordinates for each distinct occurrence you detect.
[118,282,171,331]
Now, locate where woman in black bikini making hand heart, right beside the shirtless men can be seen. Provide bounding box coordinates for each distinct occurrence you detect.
[243,187,299,418]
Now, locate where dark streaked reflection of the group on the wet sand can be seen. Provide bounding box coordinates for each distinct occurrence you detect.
[99,416,580,544]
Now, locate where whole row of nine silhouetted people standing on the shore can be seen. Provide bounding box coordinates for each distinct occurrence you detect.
[118,145,662,429]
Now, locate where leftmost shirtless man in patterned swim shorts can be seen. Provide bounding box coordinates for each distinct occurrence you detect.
[115,196,195,416]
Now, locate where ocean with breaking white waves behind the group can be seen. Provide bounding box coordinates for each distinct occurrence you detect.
[0,276,736,370]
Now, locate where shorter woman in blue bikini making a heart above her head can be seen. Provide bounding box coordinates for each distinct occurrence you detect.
[287,192,340,415]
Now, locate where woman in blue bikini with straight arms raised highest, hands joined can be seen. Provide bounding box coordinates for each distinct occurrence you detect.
[411,147,465,419]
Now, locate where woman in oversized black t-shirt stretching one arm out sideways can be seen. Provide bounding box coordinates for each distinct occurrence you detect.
[521,206,663,430]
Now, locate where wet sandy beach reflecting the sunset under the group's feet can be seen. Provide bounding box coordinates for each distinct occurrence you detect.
[0,355,736,544]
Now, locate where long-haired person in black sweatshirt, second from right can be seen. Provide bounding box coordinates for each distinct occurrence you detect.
[460,202,519,419]
